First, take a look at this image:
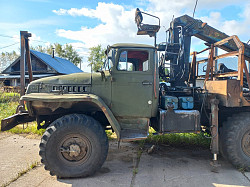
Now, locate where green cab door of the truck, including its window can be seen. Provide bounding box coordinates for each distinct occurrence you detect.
[111,48,154,118]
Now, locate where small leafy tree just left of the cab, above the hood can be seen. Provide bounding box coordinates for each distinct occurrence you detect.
[88,45,106,71]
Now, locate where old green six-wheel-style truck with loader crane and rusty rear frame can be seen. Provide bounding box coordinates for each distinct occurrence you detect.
[1,9,250,177]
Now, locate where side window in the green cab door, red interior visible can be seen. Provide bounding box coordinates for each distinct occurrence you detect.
[117,50,149,71]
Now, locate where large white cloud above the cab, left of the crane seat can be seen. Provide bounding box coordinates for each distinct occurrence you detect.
[53,3,153,48]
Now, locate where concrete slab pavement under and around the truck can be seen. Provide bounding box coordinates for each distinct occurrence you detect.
[0,133,250,187]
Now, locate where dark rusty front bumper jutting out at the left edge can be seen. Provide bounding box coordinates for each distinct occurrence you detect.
[1,113,36,131]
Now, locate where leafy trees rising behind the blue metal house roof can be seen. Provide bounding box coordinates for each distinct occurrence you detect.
[31,43,82,66]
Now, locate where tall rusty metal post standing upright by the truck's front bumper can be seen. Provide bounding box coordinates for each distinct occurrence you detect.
[20,31,32,104]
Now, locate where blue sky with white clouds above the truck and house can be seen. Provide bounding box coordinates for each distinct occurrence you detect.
[0,0,250,71]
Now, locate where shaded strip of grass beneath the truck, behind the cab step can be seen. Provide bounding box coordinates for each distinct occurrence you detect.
[145,129,211,148]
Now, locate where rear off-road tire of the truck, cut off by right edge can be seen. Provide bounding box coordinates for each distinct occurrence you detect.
[222,112,250,171]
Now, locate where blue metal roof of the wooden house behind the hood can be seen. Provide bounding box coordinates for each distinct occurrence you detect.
[30,50,83,74]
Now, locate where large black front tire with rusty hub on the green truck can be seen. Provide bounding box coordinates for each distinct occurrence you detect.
[39,114,108,178]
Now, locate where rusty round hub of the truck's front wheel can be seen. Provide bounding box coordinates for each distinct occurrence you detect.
[60,136,91,162]
